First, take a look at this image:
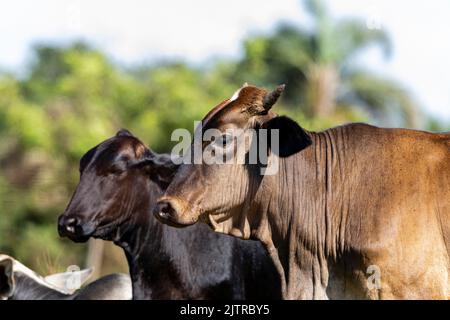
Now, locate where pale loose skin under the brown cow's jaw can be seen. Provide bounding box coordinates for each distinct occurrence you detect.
[204,213,251,239]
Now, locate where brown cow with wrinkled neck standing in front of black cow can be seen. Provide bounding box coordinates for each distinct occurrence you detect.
[153,86,450,299]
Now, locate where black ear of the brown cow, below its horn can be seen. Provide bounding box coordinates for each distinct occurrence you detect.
[262,116,312,157]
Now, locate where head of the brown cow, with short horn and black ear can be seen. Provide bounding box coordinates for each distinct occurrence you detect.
[153,85,310,238]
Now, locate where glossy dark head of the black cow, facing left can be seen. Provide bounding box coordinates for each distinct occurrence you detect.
[58,129,175,242]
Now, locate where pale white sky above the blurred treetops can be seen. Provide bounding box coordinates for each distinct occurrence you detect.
[0,0,450,121]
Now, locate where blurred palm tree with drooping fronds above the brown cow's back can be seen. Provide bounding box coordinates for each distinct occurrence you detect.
[238,0,418,127]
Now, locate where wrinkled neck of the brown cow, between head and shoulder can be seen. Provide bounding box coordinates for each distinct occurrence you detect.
[252,129,349,299]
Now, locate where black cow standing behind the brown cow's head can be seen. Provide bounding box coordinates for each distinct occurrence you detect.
[58,130,281,299]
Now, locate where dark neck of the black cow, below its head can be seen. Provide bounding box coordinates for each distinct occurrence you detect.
[115,180,196,299]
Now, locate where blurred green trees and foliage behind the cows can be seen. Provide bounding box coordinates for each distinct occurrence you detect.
[0,0,445,274]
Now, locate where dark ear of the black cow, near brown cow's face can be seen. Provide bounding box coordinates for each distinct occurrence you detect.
[132,150,179,189]
